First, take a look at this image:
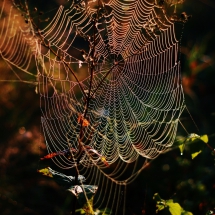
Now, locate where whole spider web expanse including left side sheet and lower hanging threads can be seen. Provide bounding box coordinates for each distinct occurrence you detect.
[0,0,185,214]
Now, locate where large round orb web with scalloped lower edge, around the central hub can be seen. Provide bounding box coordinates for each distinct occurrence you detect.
[34,1,184,167]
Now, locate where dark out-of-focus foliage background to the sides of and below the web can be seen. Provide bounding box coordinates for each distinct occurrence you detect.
[0,0,215,215]
